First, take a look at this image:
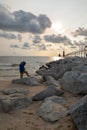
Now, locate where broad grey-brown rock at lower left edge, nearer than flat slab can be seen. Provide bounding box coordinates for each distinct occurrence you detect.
[0,94,32,113]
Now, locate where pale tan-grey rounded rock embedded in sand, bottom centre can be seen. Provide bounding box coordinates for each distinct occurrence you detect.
[38,96,68,122]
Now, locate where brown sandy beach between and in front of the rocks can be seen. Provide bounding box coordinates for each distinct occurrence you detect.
[0,80,80,130]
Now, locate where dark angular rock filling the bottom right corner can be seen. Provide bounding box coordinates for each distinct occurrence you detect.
[70,95,87,130]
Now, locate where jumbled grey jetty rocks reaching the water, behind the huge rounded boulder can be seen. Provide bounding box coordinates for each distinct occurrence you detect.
[36,57,86,80]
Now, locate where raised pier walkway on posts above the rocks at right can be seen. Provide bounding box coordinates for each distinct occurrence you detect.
[65,46,87,57]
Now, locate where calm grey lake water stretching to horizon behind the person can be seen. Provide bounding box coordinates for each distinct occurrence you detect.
[0,56,57,79]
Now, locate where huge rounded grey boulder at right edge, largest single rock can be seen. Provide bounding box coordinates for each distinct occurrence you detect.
[59,71,87,94]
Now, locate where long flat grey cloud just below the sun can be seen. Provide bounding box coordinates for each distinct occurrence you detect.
[44,34,72,44]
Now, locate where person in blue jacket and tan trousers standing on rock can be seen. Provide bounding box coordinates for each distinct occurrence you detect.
[19,61,29,79]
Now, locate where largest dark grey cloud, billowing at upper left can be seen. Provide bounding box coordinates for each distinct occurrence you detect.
[0,5,52,34]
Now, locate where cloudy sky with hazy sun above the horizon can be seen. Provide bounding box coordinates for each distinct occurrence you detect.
[0,0,87,56]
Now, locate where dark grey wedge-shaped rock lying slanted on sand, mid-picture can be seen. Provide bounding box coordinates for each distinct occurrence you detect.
[32,85,64,101]
